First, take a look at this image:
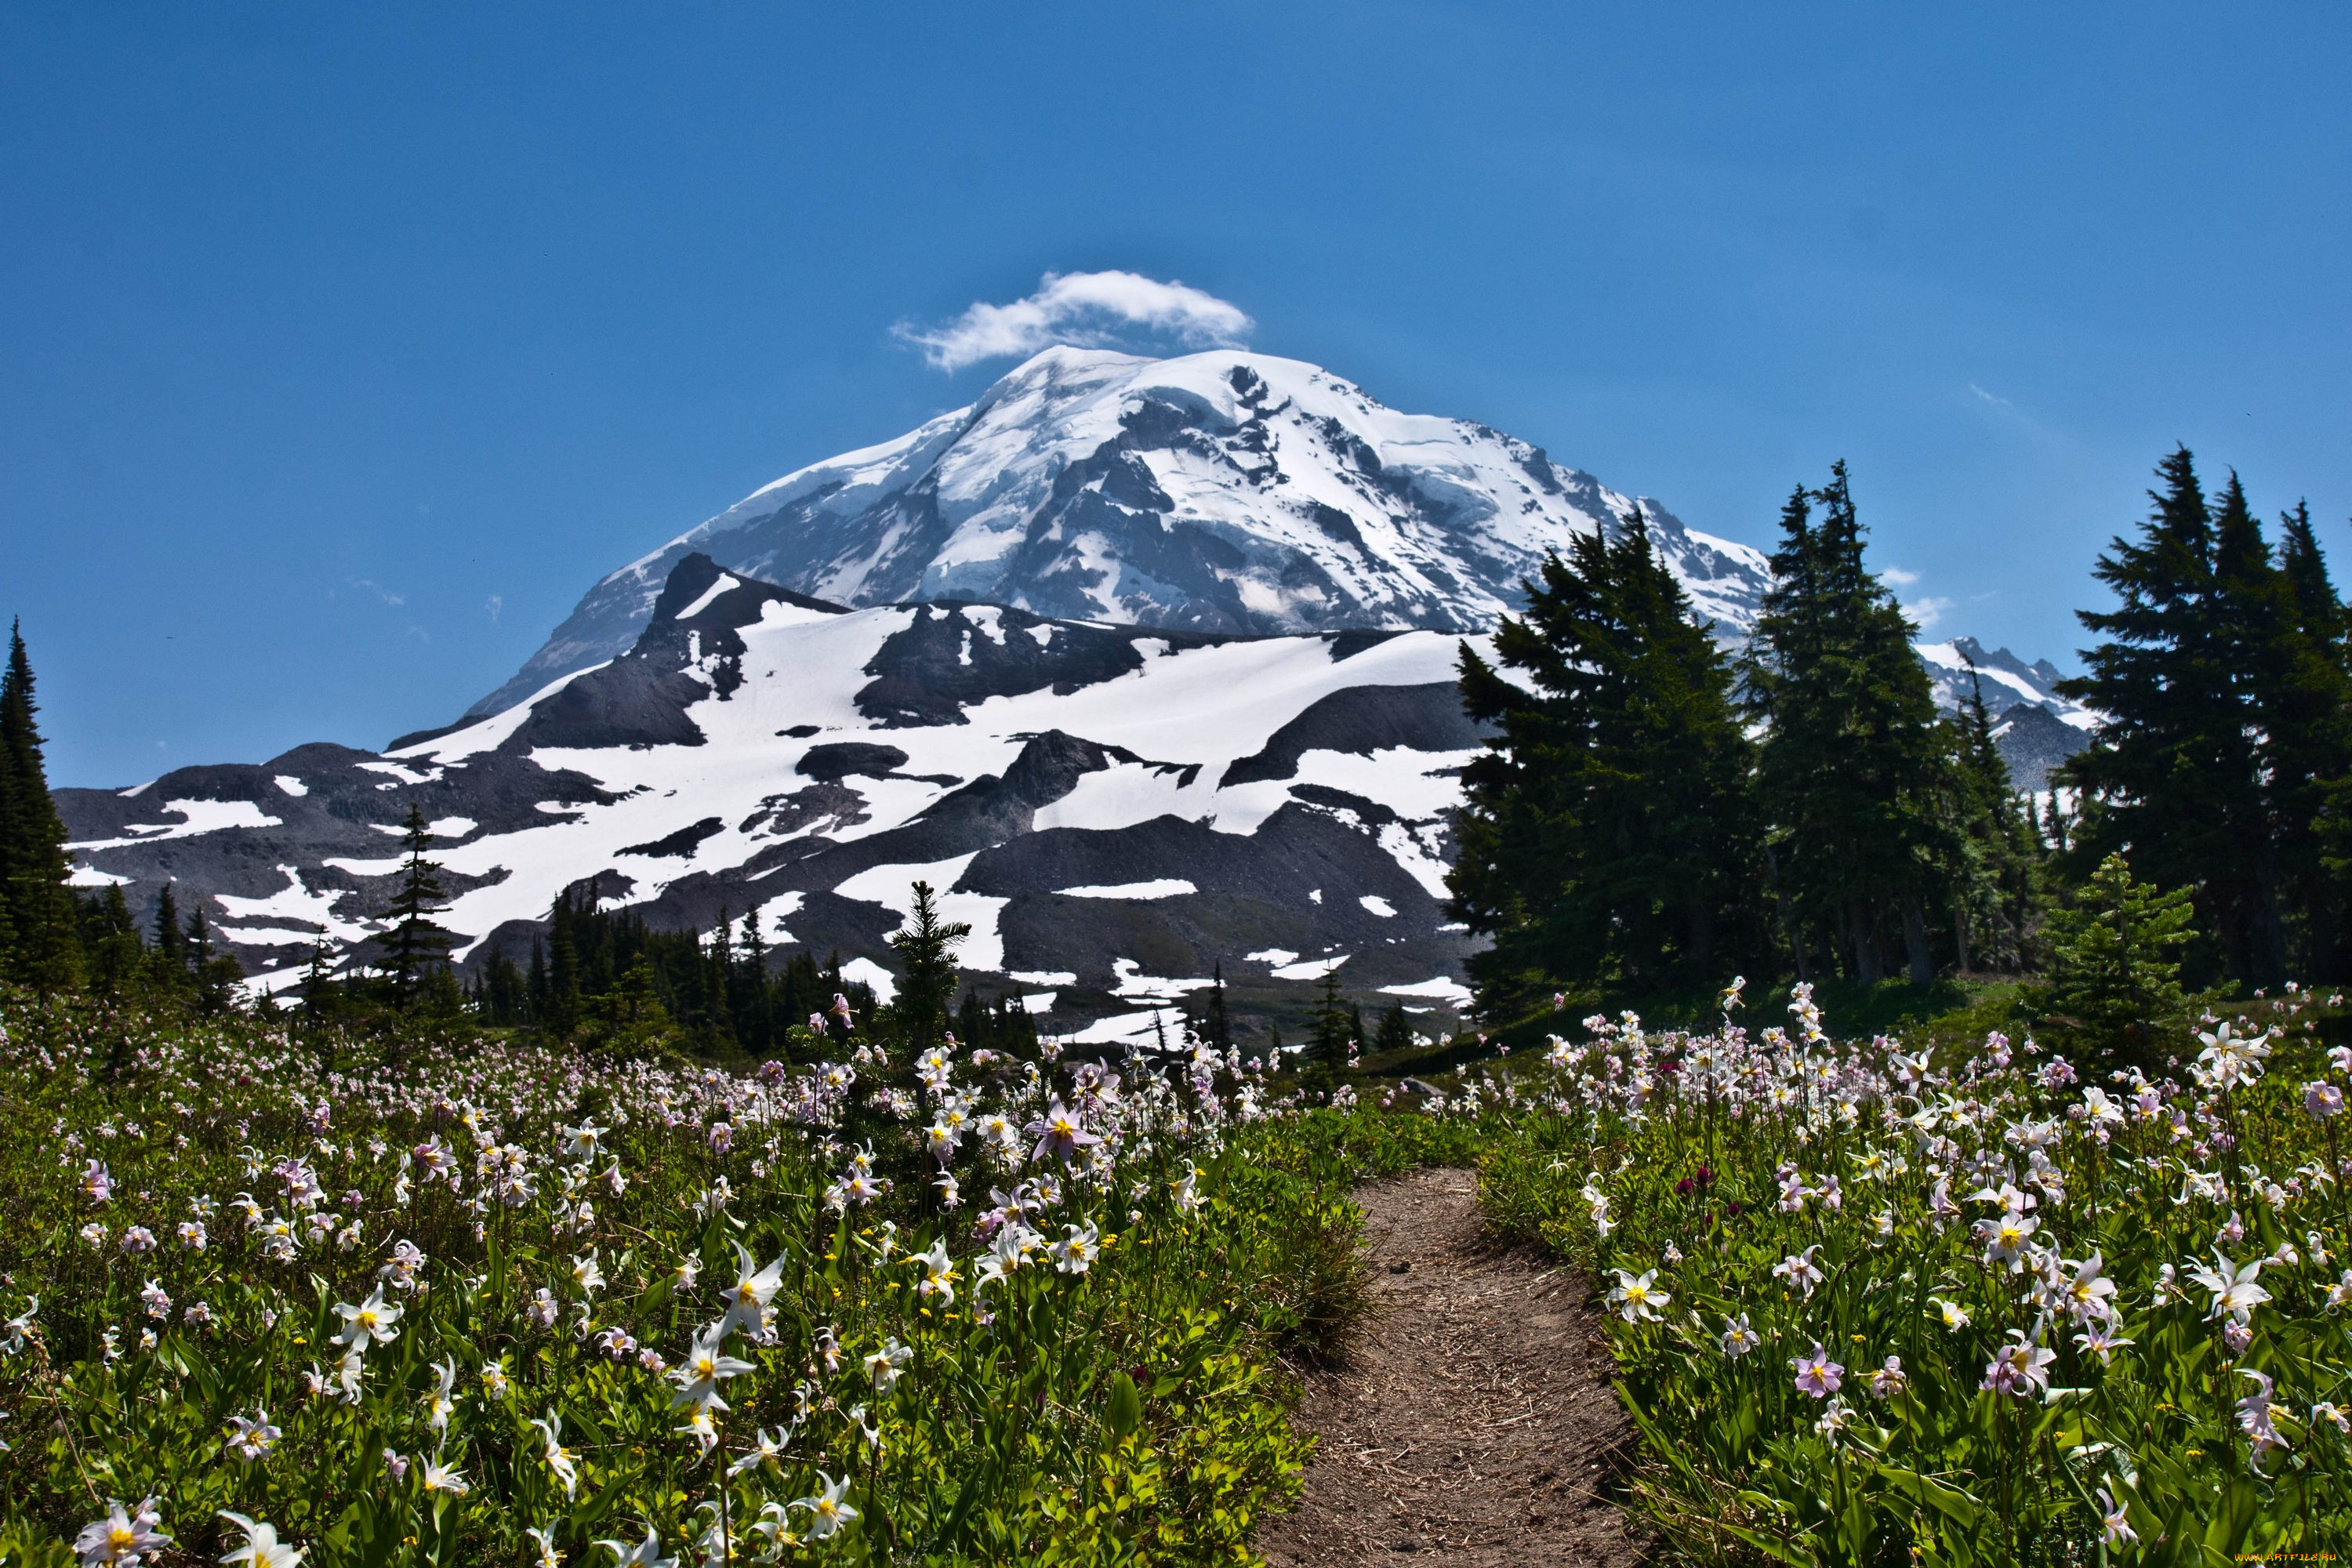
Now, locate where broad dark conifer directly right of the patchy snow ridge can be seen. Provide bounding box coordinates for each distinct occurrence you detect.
[1446,508,1759,1015]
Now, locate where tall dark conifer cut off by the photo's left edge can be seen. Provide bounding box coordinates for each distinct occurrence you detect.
[0,626,82,989]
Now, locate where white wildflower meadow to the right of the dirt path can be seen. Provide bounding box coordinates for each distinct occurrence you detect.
[1456,987,2352,1566]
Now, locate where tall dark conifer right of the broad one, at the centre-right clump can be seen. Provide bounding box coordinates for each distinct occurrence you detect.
[1743,463,1966,985]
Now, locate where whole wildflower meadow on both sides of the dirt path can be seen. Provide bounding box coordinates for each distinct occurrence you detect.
[0,987,2352,1568]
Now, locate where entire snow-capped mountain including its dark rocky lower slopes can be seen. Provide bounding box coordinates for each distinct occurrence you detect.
[59,348,2093,1039]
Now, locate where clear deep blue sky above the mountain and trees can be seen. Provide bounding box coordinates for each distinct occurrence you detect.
[0,0,2352,783]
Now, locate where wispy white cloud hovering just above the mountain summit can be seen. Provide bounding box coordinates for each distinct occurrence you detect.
[891,273,1256,372]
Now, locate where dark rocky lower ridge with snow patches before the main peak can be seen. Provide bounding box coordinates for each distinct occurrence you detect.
[59,553,1477,1039]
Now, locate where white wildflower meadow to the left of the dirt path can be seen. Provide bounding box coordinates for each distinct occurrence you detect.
[0,1004,1468,1568]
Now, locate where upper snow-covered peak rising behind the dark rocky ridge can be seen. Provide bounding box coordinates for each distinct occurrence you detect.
[470,348,1766,715]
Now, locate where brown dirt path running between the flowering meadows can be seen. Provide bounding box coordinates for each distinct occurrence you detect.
[1258,1171,1642,1568]
